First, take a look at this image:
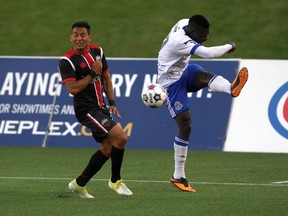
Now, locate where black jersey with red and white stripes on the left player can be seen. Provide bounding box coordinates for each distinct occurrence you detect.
[59,44,109,112]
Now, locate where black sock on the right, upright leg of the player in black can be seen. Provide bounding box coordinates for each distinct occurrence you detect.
[111,146,124,183]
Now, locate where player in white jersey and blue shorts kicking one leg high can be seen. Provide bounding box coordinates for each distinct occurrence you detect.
[157,15,248,192]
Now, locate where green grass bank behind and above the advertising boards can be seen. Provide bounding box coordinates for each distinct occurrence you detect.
[0,0,288,59]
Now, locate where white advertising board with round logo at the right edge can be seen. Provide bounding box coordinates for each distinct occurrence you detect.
[224,60,288,153]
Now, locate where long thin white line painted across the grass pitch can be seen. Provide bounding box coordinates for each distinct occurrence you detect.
[0,176,288,187]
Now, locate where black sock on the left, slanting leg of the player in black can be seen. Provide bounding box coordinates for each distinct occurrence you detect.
[76,150,109,187]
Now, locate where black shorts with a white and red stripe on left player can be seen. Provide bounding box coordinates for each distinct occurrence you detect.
[76,108,117,143]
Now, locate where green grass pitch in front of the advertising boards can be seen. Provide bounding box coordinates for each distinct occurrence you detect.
[0,147,288,216]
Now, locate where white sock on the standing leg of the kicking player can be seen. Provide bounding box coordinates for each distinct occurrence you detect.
[173,136,188,179]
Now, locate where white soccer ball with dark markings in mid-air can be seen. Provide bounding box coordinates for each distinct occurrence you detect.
[142,84,167,108]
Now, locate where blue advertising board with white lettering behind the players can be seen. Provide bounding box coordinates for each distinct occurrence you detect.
[0,57,239,150]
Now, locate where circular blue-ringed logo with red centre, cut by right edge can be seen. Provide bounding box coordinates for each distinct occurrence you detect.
[268,82,288,139]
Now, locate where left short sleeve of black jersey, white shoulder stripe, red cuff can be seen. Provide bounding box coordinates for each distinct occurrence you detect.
[59,57,76,84]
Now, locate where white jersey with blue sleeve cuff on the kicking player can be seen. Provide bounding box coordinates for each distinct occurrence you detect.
[157,19,201,87]
